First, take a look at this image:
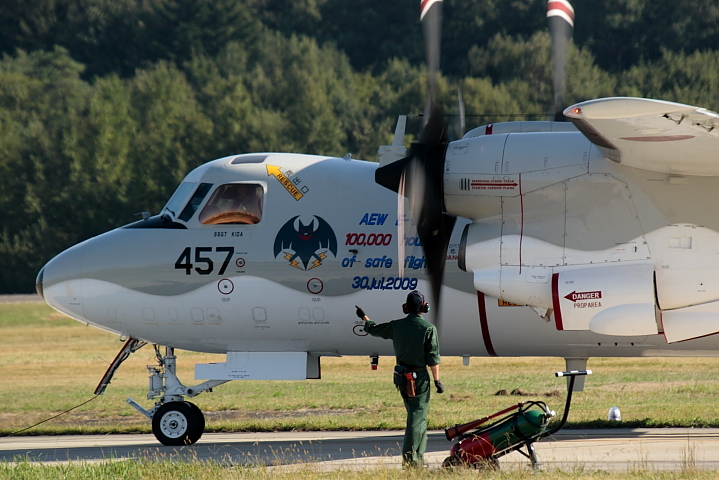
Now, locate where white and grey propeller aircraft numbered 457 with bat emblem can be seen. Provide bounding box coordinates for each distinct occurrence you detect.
[37,0,719,445]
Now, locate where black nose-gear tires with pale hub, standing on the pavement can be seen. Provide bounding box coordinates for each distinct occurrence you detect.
[152,402,205,446]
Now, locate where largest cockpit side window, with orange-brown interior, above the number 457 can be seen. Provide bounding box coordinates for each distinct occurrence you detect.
[200,183,264,225]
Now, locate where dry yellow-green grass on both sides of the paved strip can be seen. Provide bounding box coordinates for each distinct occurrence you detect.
[0,303,719,480]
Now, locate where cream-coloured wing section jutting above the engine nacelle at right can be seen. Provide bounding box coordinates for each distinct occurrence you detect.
[564,97,719,176]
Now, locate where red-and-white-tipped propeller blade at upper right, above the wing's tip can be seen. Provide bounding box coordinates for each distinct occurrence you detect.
[547,0,574,122]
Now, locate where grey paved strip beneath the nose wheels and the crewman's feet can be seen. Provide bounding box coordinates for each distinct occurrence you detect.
[0,429,719,472]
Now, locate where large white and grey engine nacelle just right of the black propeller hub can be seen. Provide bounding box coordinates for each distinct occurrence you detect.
[450,129,719,343]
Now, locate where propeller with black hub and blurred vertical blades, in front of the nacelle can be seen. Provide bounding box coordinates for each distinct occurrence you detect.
[375,0,456,326]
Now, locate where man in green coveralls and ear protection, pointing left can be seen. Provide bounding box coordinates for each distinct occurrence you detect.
[356,290,444,467]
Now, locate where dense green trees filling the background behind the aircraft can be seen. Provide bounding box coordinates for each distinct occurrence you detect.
[0,0,719,293]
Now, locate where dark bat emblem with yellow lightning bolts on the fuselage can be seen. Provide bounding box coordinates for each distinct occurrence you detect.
[273,215,337,270]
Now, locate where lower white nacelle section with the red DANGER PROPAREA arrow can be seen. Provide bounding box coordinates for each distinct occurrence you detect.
[459,224,658,336]
